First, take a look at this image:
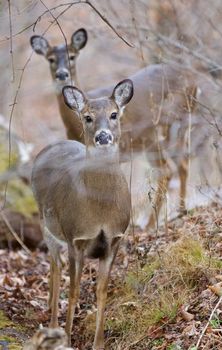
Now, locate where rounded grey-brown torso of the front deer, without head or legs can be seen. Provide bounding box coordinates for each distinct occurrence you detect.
[32,141,130,245]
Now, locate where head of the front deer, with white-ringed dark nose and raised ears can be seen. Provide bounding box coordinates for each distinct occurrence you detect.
[63,79,133,155]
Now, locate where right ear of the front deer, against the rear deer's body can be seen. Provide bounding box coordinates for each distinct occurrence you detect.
[111,79,133,108]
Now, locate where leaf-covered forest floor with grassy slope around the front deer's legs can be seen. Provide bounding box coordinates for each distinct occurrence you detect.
[0,204,222,350]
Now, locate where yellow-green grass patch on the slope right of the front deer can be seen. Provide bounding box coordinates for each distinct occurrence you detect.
[88,235,222,349]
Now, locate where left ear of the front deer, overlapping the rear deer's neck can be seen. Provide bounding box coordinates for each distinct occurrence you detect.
[62,86,86,113]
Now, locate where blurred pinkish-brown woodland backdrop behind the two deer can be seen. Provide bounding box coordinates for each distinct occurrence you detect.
[0,0,222,246]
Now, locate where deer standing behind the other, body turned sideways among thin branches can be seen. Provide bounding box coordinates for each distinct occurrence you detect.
[31,29,197,230]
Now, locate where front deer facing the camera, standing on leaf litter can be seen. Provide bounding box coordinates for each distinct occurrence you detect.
[31,79,134,350]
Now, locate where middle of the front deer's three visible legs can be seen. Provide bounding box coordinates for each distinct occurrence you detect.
[65,247,83,345]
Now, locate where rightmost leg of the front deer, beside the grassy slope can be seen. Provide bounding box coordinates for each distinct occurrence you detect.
[93,238,120,350]
